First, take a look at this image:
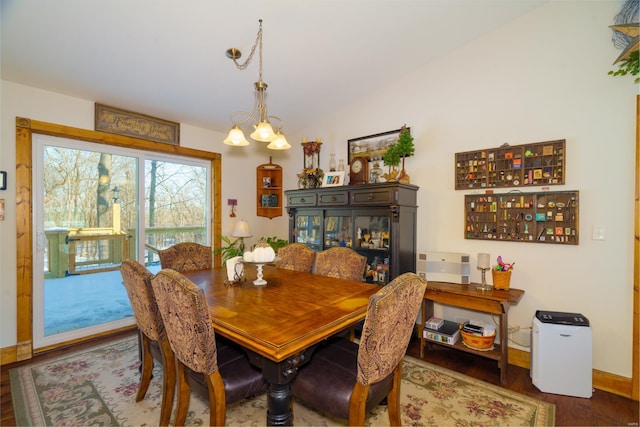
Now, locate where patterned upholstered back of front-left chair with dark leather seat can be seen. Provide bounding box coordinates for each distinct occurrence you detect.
[151,269,218,375]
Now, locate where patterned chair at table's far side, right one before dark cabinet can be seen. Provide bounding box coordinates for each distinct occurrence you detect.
[314,246,367,282]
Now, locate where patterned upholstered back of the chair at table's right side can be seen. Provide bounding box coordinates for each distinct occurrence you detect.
[357,273,427,385]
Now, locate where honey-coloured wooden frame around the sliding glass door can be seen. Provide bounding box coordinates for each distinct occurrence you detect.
[16,117,222,360]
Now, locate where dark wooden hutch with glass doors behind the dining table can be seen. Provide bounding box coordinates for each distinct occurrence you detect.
[285,182,418,285]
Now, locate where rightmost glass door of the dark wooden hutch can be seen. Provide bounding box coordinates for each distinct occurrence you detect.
[353,215,391,285]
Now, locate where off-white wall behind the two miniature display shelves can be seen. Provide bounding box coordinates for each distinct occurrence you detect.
[298,1,638,377]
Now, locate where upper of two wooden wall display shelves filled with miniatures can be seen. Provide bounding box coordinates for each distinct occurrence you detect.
[455,139,566,190]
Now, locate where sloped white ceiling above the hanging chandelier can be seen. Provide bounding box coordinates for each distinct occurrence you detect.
[1,0,544,133]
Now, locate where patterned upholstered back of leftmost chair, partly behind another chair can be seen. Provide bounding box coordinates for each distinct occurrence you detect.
[120,259,167,341]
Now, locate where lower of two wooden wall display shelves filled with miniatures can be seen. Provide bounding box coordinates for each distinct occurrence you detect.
[464,191,579,245]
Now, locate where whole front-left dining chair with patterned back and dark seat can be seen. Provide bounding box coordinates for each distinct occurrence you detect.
[151,269,267,426]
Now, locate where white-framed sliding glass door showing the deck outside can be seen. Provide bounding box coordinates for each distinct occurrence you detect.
[33,135,210,348]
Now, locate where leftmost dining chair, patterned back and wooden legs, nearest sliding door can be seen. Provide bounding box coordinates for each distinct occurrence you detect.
[120,259,176,426]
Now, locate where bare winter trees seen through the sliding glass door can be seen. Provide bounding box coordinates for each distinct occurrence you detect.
[44,146,209,270]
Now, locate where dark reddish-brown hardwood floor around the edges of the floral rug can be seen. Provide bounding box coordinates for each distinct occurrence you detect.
[0,332,640,426]
